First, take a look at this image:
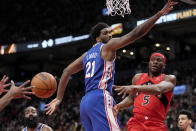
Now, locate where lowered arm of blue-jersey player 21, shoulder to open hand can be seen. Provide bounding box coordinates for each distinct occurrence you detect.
[45,53,85,115]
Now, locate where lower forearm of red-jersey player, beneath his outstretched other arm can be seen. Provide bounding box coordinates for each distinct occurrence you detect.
[118,96,134,110]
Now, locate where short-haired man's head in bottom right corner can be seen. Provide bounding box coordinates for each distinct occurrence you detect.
[178,110,193,130]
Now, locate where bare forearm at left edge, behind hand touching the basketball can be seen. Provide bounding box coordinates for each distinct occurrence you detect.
[0,92,14,111]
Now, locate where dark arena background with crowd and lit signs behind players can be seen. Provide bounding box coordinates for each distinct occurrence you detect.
[0,0,196,131]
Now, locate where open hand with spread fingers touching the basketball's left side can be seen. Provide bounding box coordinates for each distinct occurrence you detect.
[8,80,34,99]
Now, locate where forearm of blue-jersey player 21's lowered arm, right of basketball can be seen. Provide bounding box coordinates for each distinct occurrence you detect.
[57,69,70,101]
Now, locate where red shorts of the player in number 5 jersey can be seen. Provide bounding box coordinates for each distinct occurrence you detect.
[128,114,167,131]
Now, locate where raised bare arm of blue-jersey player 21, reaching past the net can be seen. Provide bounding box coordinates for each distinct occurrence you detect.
[103,0,177,51]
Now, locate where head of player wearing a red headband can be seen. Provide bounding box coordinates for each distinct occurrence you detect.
[149,52,166,75]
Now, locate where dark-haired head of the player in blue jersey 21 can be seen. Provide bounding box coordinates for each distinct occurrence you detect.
[90,23,112,43]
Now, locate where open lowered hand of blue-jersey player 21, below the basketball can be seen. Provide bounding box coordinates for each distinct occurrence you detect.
[44,98,61,115]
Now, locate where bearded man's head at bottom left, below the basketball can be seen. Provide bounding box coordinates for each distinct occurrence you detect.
[24,106,39,128]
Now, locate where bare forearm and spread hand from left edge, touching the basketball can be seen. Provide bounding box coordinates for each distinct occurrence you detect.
[0,80,33,111]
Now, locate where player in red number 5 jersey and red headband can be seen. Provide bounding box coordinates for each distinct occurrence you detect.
[114,53,176,131]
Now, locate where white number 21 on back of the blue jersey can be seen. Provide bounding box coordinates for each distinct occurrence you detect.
[85,61,95,78]
